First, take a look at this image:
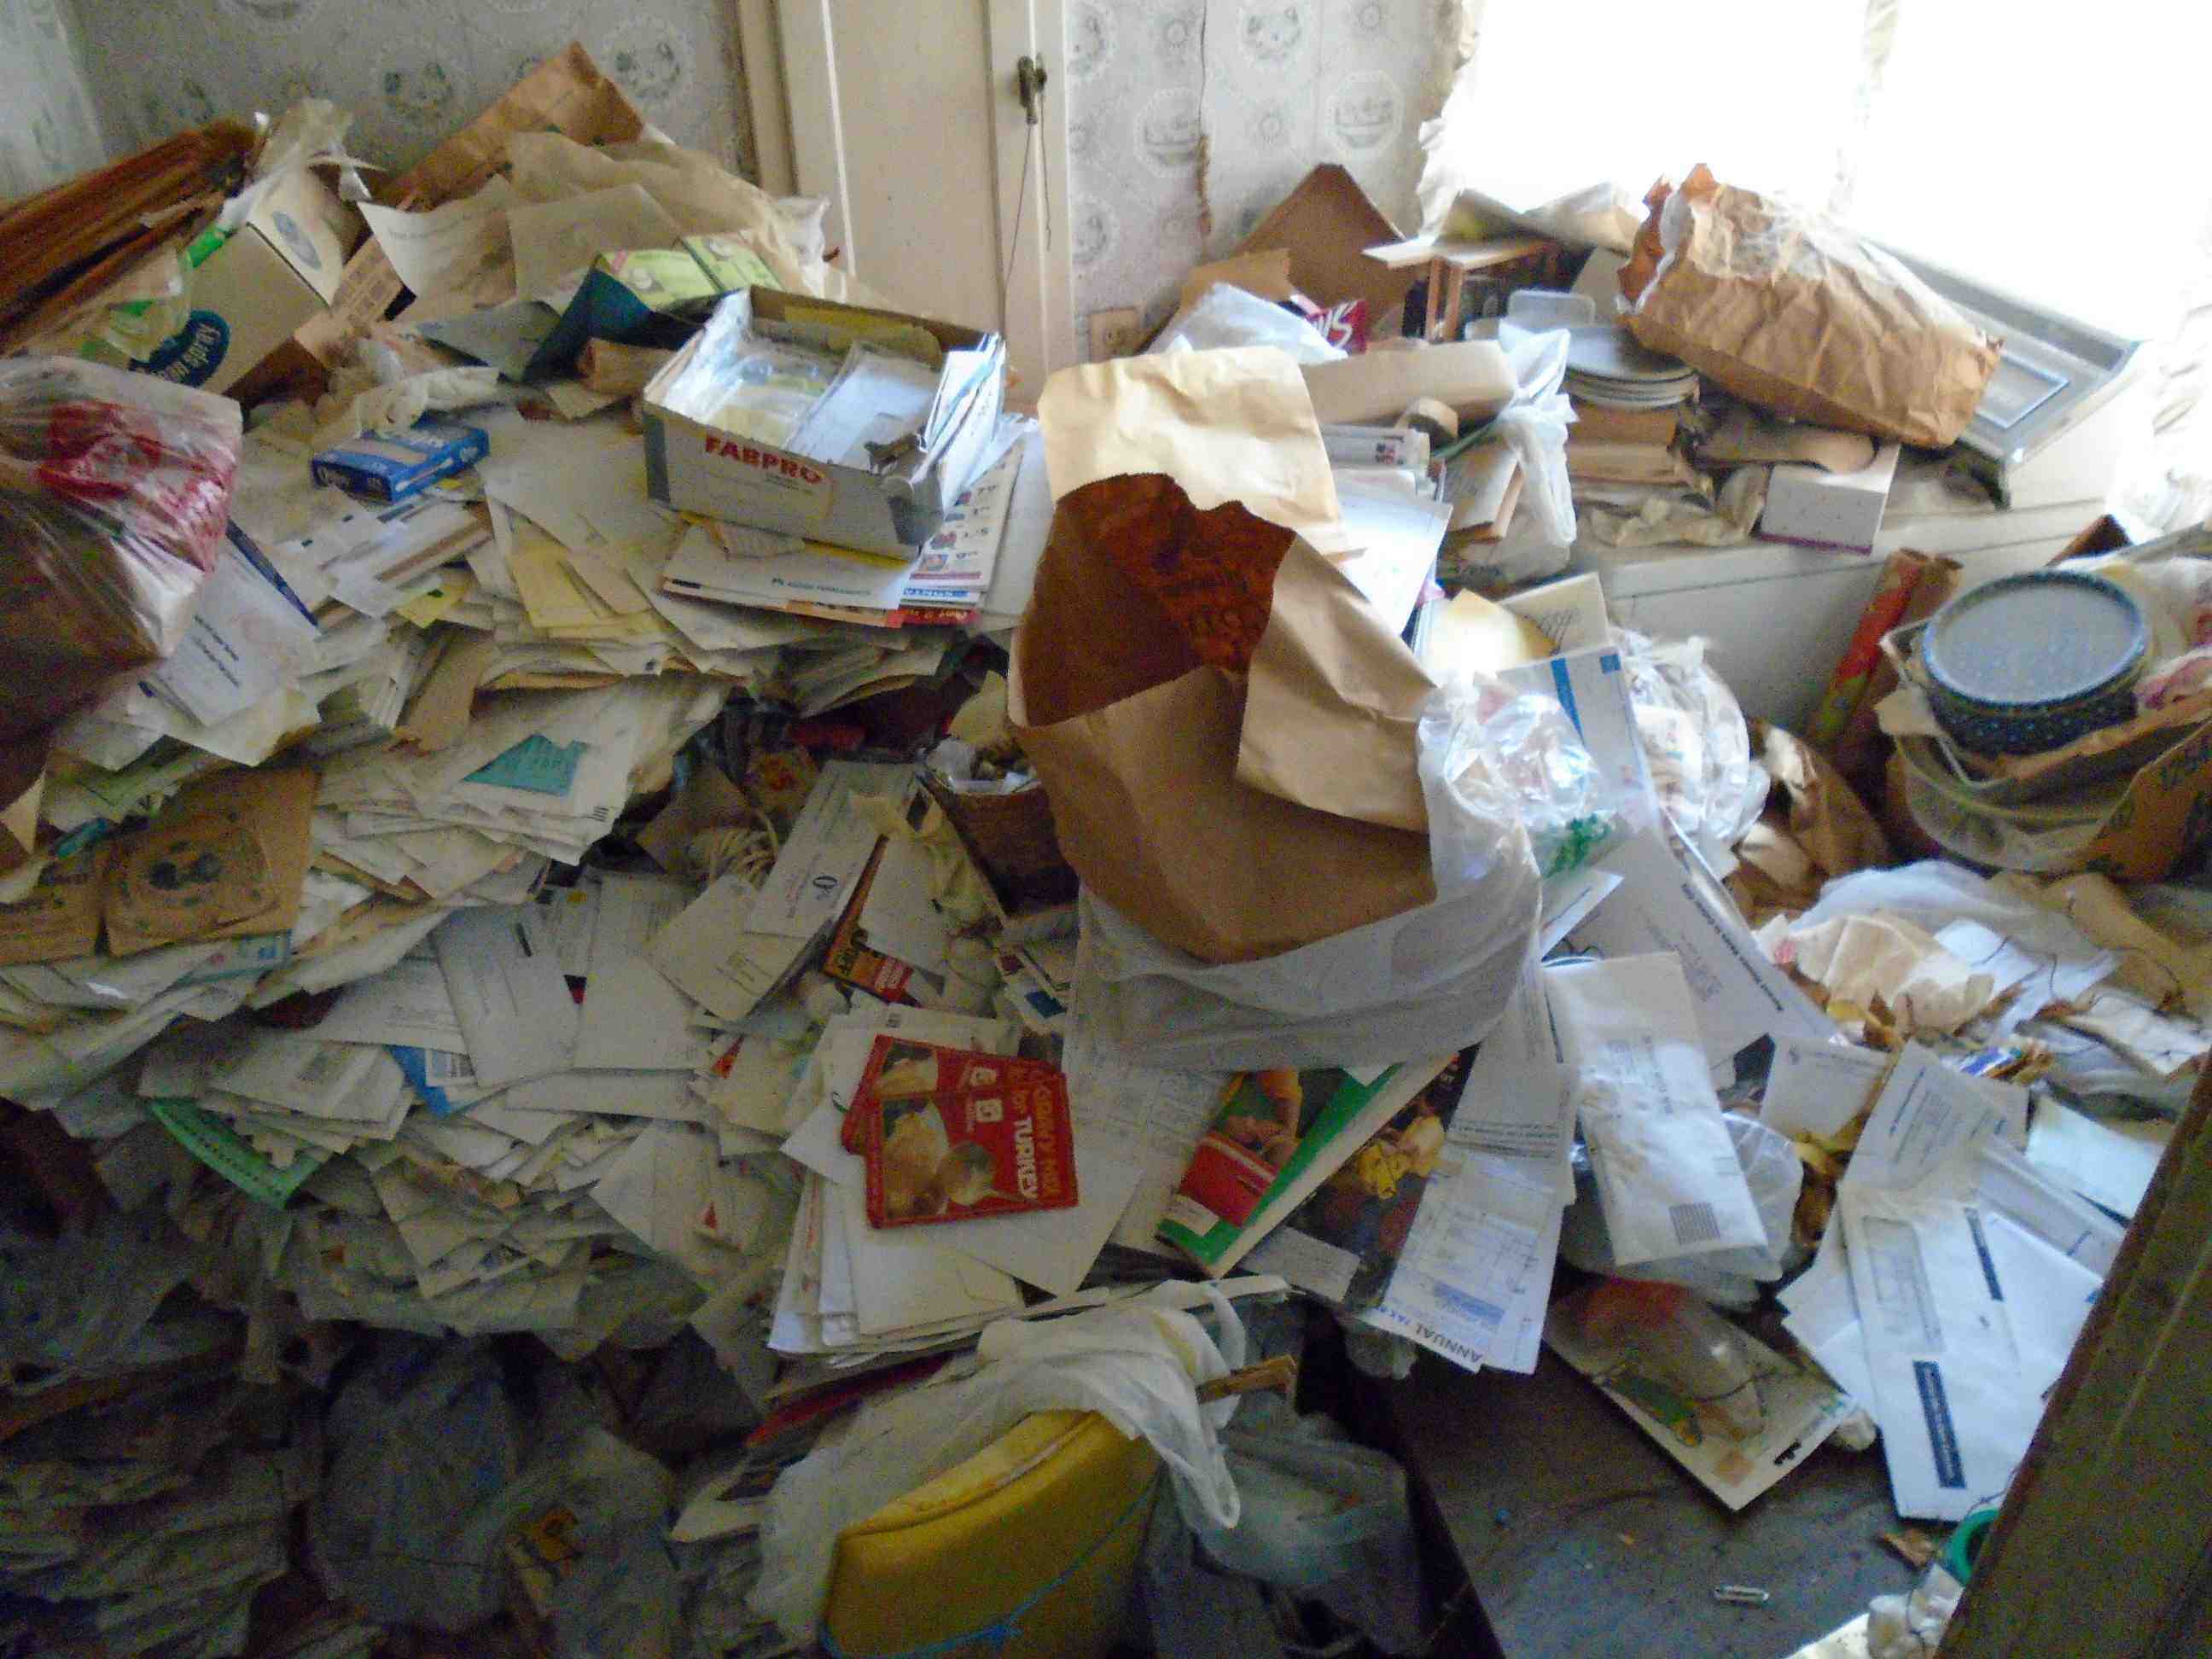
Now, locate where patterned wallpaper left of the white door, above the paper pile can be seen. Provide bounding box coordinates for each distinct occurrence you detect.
[64,0,752,172]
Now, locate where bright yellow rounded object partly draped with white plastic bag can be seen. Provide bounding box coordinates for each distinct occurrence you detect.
[823,1412,1159,1659]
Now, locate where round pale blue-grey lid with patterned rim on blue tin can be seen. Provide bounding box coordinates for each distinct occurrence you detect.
[1922,571,2150,710]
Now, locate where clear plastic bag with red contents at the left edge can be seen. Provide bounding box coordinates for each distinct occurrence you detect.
[0,358,242,741]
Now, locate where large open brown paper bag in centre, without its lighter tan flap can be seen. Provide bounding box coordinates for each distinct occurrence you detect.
[1009,475,1435,963]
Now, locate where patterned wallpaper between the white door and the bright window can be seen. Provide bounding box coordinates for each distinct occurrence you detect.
[1064,0,1460,350]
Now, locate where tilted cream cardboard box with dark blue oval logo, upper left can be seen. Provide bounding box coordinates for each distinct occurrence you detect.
[146,172,367,392]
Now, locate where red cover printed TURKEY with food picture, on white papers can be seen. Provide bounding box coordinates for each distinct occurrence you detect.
[845,1038,1075,1228]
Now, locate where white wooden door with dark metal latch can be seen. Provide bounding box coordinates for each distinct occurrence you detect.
[739,0,1075,403]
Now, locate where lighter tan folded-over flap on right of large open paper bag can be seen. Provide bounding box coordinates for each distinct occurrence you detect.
[1237,542,1435,832]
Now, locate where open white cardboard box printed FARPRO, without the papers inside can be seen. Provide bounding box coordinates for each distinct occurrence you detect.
[643,288,1006,556]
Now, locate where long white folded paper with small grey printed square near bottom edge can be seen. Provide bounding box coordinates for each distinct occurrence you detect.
[1544,956,1767,1266]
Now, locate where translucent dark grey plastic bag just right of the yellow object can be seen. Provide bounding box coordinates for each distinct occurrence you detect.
[1192,1402,1423,1652]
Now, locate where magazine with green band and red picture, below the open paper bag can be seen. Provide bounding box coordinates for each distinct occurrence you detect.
[1159,1055,1456,1277]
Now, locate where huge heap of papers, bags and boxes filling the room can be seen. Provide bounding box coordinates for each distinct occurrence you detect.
[0,35,2212,1659]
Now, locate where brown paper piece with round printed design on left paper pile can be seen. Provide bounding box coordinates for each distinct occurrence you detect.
[104,767,317,956]
